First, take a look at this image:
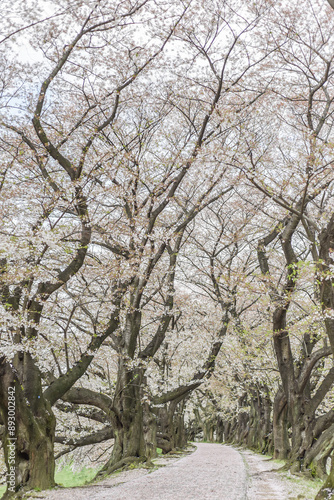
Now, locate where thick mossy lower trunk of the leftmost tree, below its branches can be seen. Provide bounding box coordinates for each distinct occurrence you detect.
[0,353,55,497]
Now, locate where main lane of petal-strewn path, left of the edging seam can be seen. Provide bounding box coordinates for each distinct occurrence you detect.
[89,443,247,500]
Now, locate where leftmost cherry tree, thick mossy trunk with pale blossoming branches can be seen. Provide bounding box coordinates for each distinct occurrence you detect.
[1,1,185,494]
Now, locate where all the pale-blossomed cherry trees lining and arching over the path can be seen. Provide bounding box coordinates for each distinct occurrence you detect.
[0,0,334,498]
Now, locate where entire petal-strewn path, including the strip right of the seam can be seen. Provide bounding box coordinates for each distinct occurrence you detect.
[38,443,314,500]
